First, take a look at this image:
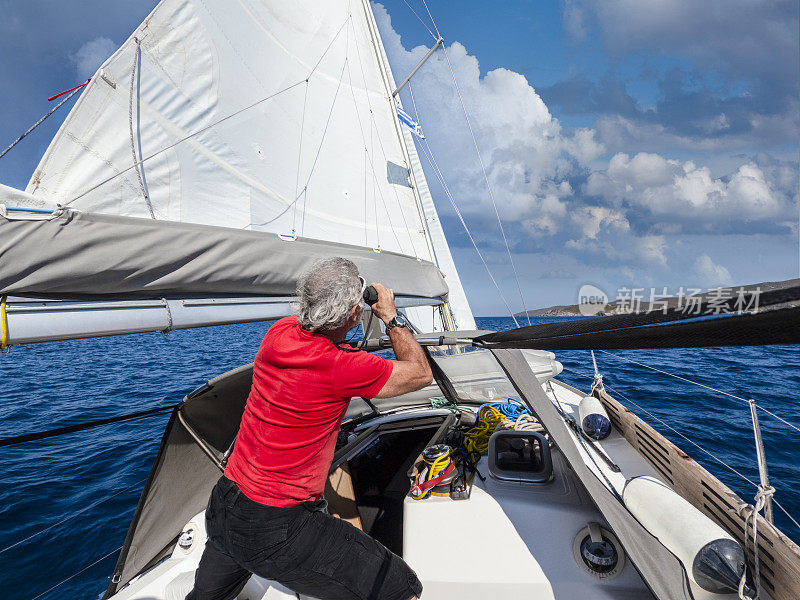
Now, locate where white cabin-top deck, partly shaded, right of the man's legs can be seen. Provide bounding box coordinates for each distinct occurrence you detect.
[403,452,653,600]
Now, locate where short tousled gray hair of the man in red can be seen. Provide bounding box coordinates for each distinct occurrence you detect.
[294,257,361,331]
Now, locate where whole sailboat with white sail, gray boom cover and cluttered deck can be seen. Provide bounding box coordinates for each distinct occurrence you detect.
[0,0,800,600]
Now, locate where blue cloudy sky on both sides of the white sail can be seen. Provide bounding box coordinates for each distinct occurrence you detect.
[0,0,800,315]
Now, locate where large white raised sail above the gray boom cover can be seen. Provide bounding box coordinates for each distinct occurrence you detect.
[26,0,474,329]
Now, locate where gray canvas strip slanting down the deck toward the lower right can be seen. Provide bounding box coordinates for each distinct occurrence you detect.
[492,350,693,600]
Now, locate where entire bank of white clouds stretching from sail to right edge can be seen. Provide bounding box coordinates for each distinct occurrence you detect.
[374,0,798,278]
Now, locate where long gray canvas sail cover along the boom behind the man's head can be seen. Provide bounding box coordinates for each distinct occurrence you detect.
[0,210,448,299]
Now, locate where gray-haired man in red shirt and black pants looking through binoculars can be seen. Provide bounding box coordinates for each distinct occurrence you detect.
[187,258,432,600]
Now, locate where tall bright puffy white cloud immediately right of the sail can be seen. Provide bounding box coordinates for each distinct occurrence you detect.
[374,4,603,221]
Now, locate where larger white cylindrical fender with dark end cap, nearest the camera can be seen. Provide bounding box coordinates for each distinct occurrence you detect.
[622,475,744,593]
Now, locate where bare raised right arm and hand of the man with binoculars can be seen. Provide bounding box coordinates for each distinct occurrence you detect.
[372,283,433,398]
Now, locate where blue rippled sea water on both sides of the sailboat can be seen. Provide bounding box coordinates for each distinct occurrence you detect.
[0,318,800,600]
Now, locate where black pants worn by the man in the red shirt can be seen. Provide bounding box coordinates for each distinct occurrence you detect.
[186,477,422,600]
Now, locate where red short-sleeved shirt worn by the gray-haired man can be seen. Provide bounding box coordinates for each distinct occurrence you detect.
[225,317,392,506]
